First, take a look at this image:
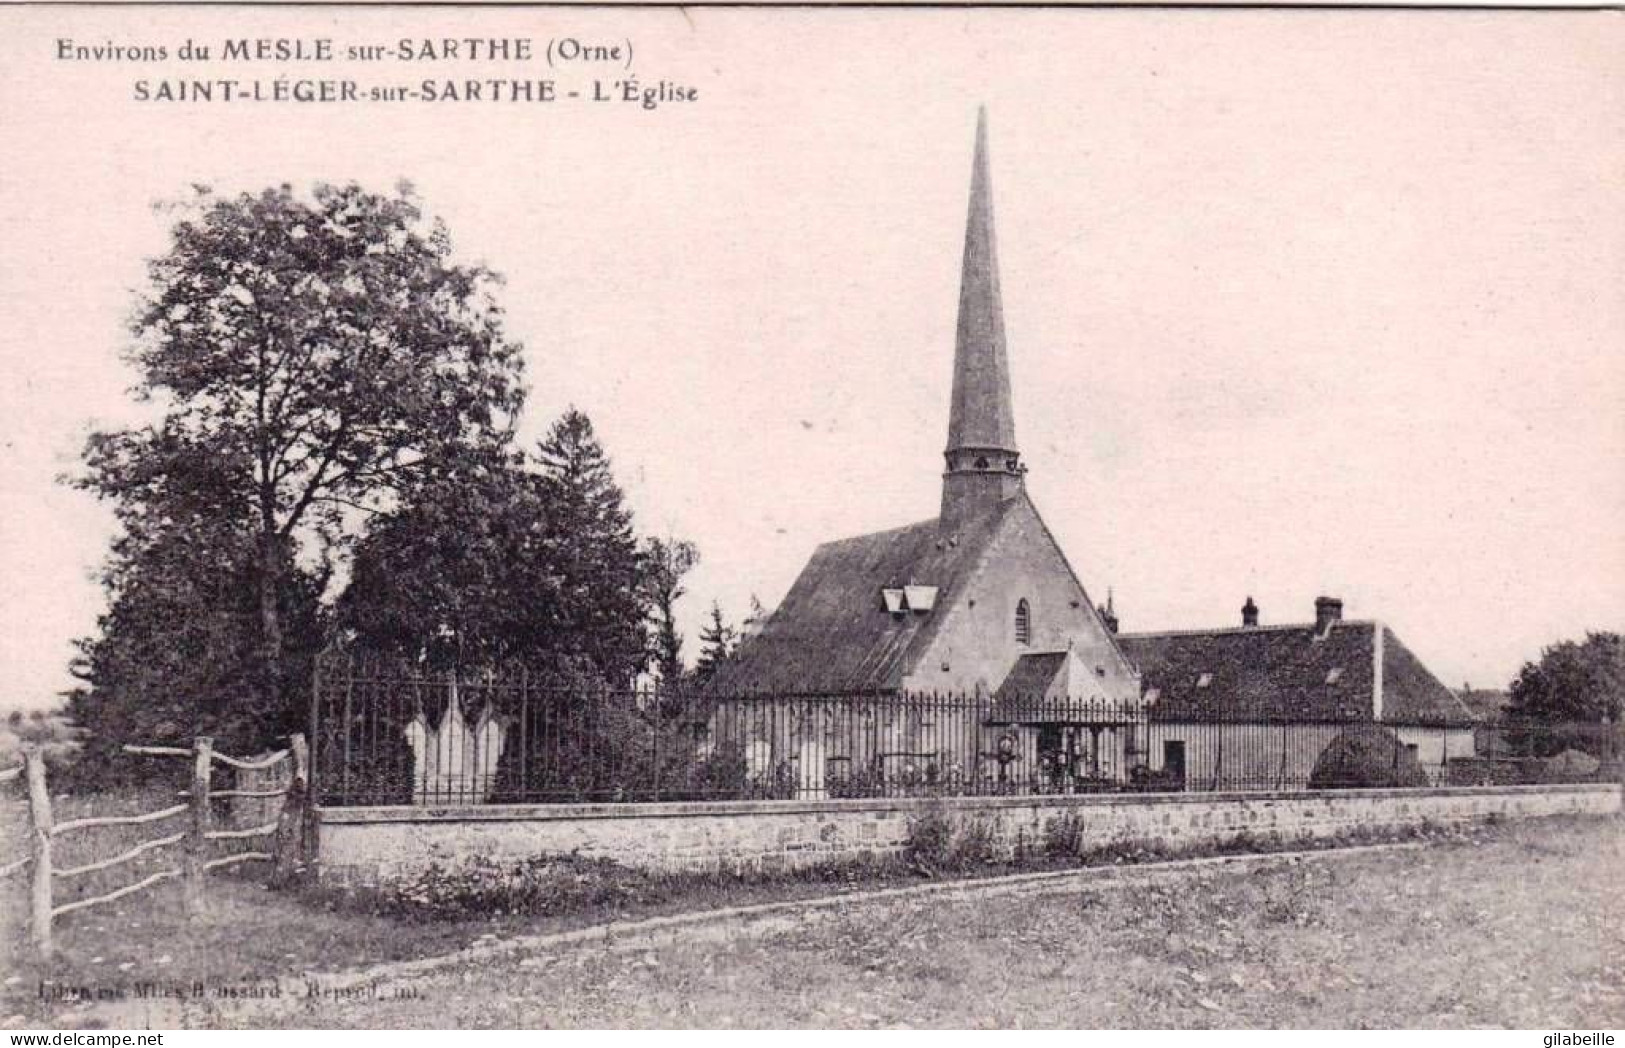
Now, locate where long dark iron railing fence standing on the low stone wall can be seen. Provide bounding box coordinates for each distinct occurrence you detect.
[310,653,1622,806]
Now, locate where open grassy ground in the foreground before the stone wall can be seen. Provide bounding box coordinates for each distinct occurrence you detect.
[8,817,1625,1029]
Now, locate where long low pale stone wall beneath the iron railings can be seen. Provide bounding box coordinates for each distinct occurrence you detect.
[319,785,1620,884]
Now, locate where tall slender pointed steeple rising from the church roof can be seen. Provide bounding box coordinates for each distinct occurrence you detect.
[941,109,1025,531]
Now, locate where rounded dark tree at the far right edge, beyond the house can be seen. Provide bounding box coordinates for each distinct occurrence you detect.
[1506,632,1625,756]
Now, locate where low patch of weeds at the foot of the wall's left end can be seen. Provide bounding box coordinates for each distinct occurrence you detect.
[382,855,666,918]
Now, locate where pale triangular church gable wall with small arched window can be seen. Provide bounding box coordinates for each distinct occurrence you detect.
[902,492,1139,702]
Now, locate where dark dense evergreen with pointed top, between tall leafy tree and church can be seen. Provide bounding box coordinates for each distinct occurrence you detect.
[338,409,647,687]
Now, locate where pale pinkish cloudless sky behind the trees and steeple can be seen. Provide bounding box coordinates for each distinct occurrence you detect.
[0,8,1625,708]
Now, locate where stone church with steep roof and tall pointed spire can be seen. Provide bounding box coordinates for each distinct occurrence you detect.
[710,112,1141,786]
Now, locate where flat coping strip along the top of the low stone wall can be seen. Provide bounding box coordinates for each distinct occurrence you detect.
[317,783,1625,825]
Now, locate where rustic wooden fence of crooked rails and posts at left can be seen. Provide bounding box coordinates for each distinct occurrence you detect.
[0,734,310,954]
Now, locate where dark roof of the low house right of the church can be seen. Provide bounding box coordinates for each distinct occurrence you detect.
[1118,621,1476,725]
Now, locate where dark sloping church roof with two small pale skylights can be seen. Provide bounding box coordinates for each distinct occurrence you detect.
[710,499,1021,694]
